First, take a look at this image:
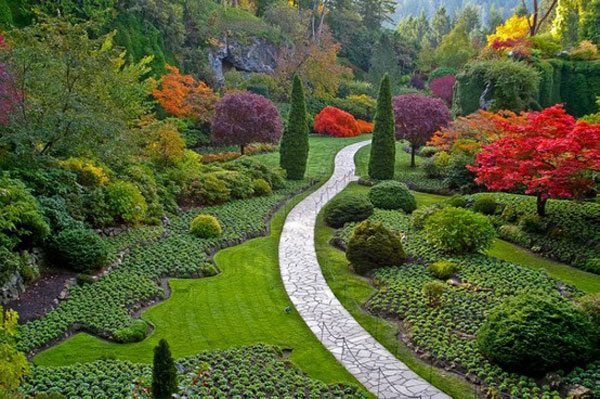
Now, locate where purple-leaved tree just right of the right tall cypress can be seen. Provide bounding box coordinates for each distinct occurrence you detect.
[393,94,451,148]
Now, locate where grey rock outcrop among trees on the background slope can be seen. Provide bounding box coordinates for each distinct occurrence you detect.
[208,37,278,85]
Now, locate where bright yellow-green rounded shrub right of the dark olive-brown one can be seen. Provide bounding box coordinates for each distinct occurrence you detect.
[423,207,496,255]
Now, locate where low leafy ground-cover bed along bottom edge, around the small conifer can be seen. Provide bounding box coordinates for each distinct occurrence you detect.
[21,345,367,399]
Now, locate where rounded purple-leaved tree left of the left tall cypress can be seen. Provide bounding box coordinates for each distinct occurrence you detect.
[212,91,283,147]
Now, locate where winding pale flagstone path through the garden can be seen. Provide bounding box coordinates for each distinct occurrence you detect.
[279,141,449,399]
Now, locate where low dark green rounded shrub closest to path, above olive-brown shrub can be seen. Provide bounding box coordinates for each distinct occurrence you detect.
[323,194,373,228]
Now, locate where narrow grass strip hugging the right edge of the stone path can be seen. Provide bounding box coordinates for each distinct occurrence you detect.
[315,184,476,398]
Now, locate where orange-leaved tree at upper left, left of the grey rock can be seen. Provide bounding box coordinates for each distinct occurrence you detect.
[152,65,219,123]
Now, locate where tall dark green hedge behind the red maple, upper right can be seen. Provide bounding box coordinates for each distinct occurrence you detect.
[453,59,600,117]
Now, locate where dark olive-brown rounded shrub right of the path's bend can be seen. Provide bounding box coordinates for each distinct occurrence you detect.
[346,220,406,274]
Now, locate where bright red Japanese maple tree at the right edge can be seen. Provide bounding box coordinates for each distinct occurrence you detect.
[467,105,600,216]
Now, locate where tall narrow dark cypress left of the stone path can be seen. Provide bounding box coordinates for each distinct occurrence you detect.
[279,75,308,180]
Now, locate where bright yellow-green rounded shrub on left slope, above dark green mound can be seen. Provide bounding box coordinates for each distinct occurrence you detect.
[106,180,148,223]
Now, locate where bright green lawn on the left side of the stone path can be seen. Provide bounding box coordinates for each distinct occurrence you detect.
[34,137,364,390]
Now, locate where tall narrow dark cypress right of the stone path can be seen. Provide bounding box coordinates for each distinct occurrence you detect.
[369,74,396,180]
